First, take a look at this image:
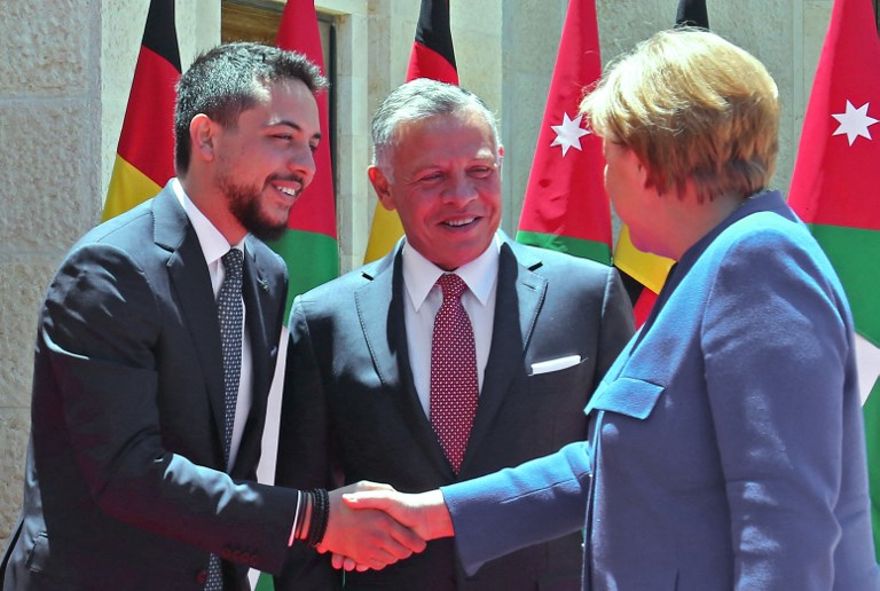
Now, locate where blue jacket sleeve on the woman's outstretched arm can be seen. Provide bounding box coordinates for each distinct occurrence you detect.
[440,441,590,575]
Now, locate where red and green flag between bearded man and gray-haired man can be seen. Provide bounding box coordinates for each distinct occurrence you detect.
[269,0,339,312]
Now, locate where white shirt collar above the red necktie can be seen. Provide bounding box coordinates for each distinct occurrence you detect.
[401,234,501,310]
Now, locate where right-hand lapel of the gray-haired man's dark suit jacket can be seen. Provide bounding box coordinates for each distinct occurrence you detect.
[462,240,547,470]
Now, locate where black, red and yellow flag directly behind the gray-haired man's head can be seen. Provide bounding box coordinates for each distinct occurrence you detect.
[364,0,458,263]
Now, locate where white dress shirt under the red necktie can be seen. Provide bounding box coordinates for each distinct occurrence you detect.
[401,235,501,419]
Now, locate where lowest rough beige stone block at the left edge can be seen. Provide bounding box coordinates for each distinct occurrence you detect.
[0,408,30,555]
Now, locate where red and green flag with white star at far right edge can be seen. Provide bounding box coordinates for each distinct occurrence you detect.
[789,0,880,550]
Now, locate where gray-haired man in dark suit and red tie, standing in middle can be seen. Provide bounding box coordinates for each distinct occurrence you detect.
[276,79,632,591]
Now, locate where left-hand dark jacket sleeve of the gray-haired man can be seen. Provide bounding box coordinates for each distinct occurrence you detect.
[275,297,342,591]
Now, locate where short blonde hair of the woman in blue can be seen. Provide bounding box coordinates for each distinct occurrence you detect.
[581,28,779,201]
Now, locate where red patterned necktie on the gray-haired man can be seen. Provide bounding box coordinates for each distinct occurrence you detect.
[430,273,479,474]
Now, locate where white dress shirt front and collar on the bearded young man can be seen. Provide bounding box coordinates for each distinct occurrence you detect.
[171,179,253,471]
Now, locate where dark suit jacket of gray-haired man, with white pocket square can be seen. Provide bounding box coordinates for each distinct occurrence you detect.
[276,240,632,591]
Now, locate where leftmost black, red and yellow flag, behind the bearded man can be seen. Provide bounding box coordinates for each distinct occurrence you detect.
[101,0,180,220]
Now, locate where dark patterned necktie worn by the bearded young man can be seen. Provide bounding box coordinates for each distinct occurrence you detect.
[205,248,244,591]
